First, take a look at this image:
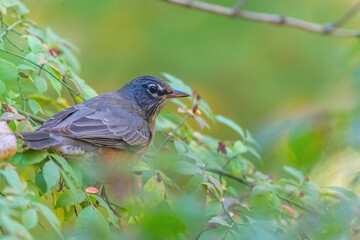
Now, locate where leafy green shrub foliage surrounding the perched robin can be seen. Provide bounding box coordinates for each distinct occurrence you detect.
[0,0,360,239]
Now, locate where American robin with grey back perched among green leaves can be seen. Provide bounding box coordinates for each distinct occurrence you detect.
[21,76,189,160]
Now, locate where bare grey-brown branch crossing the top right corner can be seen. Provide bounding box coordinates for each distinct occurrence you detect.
[163,0,360,37]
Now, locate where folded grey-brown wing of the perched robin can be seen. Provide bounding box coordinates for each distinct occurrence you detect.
[40,97,152,149]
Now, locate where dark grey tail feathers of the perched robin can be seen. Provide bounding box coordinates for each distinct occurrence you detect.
[18,131,61,150]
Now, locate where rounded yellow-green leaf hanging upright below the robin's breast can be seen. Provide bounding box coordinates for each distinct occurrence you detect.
[143,176,165,207]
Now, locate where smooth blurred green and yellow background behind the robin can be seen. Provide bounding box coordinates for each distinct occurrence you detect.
[25,0,360,187]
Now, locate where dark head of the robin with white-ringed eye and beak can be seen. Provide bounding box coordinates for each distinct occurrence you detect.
[122,76,190,119]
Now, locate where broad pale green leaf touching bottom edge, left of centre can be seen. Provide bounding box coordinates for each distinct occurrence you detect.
[75,206,112,239]
